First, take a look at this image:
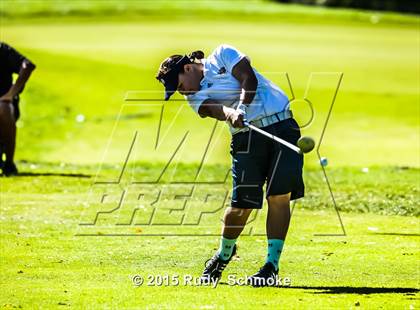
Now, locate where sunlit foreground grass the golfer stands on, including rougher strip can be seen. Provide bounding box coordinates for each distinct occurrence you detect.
[0,163,420,309]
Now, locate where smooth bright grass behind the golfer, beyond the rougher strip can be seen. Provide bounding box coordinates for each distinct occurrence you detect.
[1,1,420,167]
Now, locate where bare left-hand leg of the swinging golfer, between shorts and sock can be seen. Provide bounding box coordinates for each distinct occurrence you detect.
[222,207,252,239]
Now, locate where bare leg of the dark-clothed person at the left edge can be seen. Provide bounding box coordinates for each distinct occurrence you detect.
[0,101,16,163]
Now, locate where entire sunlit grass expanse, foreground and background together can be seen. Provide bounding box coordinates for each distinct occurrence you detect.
[0,0,420,309]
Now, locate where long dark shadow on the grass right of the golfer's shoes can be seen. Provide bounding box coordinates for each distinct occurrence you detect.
[287,286,420,295]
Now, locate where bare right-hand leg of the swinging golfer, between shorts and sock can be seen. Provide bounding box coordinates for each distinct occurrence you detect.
[266,193,290,240]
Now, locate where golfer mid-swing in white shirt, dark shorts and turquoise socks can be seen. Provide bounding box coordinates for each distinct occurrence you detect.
[156,45,304,286]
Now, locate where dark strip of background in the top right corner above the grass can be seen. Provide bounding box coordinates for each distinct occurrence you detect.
[276,0,420,14]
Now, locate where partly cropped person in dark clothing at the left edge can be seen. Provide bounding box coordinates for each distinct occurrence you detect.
[0,42,35,176]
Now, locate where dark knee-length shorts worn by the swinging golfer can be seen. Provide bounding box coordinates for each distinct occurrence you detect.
[230,118,305,209]
